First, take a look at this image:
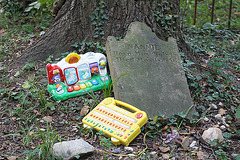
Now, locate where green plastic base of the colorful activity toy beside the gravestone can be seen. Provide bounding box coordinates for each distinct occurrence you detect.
[47,75,111,101]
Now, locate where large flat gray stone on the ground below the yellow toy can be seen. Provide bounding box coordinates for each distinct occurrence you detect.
[53,139,94,160]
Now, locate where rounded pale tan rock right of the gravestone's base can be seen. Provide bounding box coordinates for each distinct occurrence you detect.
[202,128,223,143]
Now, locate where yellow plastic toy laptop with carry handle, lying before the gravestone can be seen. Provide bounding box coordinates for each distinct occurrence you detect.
[82,98,148,146]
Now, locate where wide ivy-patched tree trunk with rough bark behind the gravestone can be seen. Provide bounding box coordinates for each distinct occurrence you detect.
[19,0,194,62]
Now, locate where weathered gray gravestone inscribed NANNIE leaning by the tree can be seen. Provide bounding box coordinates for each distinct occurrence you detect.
[106,22,193,118]
